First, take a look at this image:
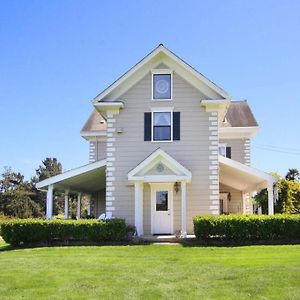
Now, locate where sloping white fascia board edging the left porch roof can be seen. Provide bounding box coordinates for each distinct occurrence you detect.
[36,159,106,189]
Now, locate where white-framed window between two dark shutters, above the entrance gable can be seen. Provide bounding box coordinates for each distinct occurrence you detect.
[153,112,172,141]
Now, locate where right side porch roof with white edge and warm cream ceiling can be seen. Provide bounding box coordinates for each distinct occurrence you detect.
[219,155,276,192]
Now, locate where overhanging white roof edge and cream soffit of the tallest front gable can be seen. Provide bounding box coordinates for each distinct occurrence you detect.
[93,44,230,104]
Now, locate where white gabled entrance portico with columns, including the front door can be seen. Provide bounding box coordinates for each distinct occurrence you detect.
[128,149,192,238]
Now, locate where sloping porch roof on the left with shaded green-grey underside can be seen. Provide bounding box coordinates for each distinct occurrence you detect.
[36,159,106,193]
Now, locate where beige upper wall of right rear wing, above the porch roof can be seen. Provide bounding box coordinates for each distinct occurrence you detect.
[219,139,250,165]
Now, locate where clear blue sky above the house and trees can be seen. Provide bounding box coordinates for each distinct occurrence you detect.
[0,0,300,178]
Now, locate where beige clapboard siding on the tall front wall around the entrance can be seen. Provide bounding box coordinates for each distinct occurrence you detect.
[109,73,218,232]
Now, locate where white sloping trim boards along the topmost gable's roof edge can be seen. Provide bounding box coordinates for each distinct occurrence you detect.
[92,45,230,103]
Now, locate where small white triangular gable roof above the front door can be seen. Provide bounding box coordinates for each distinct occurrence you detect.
[127,148,192,182]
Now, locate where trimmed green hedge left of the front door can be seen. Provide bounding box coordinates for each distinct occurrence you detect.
[0,219,134,245]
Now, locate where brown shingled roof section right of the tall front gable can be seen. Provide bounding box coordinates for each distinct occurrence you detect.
[222,100,258,127]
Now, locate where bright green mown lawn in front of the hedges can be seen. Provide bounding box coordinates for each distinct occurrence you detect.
[0,242,300,299]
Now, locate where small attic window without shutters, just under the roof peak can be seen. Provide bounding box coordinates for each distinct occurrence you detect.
[152,69,173,100]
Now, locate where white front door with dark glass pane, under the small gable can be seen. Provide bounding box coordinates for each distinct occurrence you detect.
[151,185,173,234]
